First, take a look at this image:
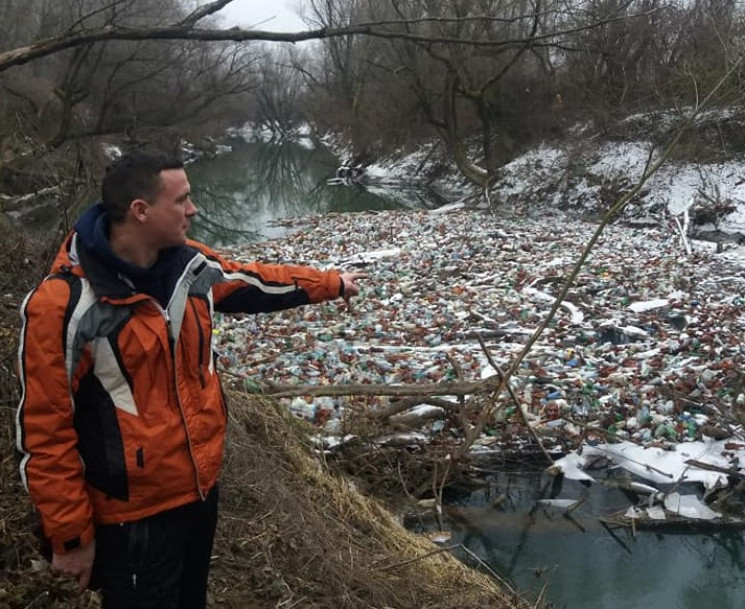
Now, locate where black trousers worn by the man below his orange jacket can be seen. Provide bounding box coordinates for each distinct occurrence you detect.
[91,487,217,609]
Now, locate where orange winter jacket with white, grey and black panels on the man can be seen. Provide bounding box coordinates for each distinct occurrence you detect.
[17,233,344,553]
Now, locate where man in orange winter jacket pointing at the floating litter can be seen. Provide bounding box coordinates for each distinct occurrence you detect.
[17,152,364,609]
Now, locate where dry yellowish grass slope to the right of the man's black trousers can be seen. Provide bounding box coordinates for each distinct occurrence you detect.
[212,392,527,609]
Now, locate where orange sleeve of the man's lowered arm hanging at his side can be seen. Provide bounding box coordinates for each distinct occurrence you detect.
[16,278,94,554]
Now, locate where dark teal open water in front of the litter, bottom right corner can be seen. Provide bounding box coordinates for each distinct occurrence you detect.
[430,474,745,609]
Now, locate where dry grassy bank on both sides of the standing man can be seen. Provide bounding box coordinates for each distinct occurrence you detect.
[0,229,529,609]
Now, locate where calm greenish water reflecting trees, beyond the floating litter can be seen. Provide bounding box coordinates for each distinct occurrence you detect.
[189,140,440,245]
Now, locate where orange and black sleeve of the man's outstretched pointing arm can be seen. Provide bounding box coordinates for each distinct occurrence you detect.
[193,244,344,313]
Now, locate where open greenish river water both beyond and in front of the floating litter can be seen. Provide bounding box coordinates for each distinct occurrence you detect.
[189,141,745,609]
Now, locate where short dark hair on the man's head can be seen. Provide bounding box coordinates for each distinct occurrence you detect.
[101,151,184,224]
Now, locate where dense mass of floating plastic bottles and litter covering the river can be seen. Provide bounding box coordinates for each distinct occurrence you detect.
[216,202,745,520]
